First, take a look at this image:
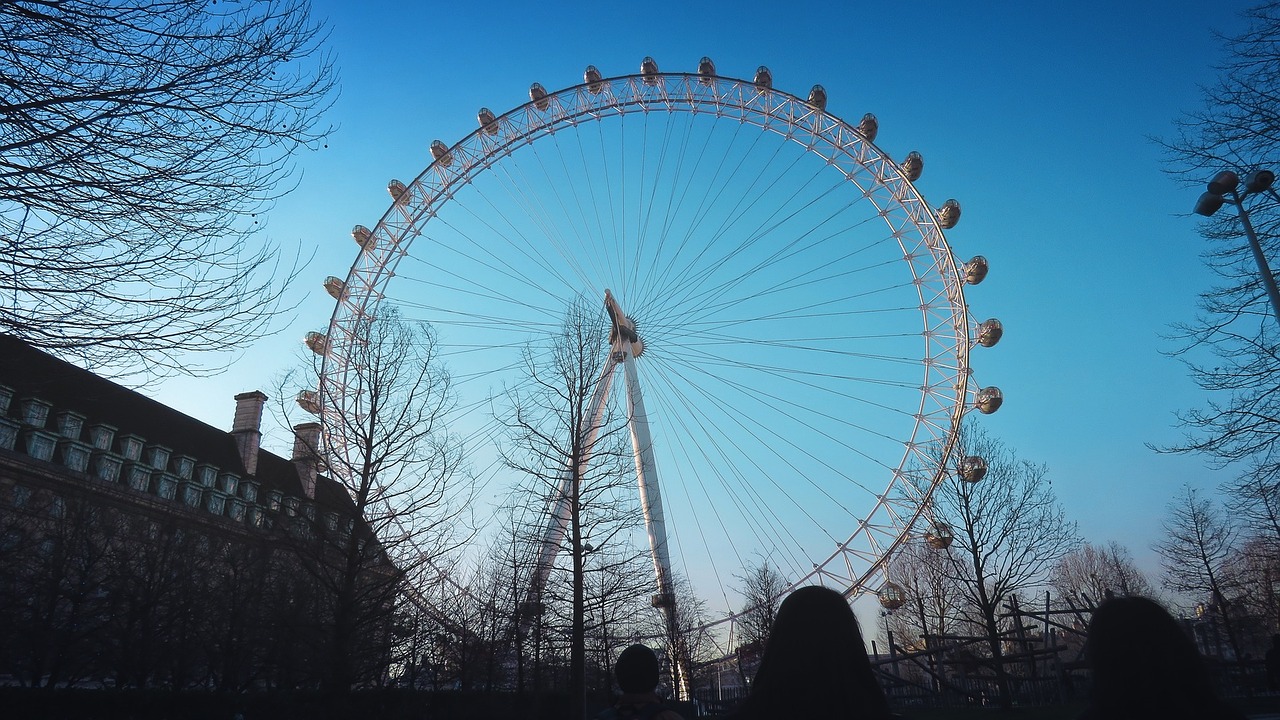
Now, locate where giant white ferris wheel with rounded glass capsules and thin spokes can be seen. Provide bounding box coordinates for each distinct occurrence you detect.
[307,58,1002,638]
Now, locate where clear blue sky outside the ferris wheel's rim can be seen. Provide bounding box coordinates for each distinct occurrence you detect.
[155,0,1266,622]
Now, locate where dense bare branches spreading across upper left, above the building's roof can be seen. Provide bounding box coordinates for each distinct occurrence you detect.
[0,0,334,372]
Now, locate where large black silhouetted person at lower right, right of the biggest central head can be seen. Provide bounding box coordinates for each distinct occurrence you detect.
[1084,597,1244,720]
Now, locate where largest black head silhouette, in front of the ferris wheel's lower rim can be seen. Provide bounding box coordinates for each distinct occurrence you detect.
[736,585,891,720]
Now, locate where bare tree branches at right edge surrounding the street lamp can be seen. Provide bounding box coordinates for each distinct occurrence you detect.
[1161,0,1280,493]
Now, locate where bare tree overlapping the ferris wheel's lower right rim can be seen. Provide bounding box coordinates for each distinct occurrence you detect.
[933,427,1079,707]
